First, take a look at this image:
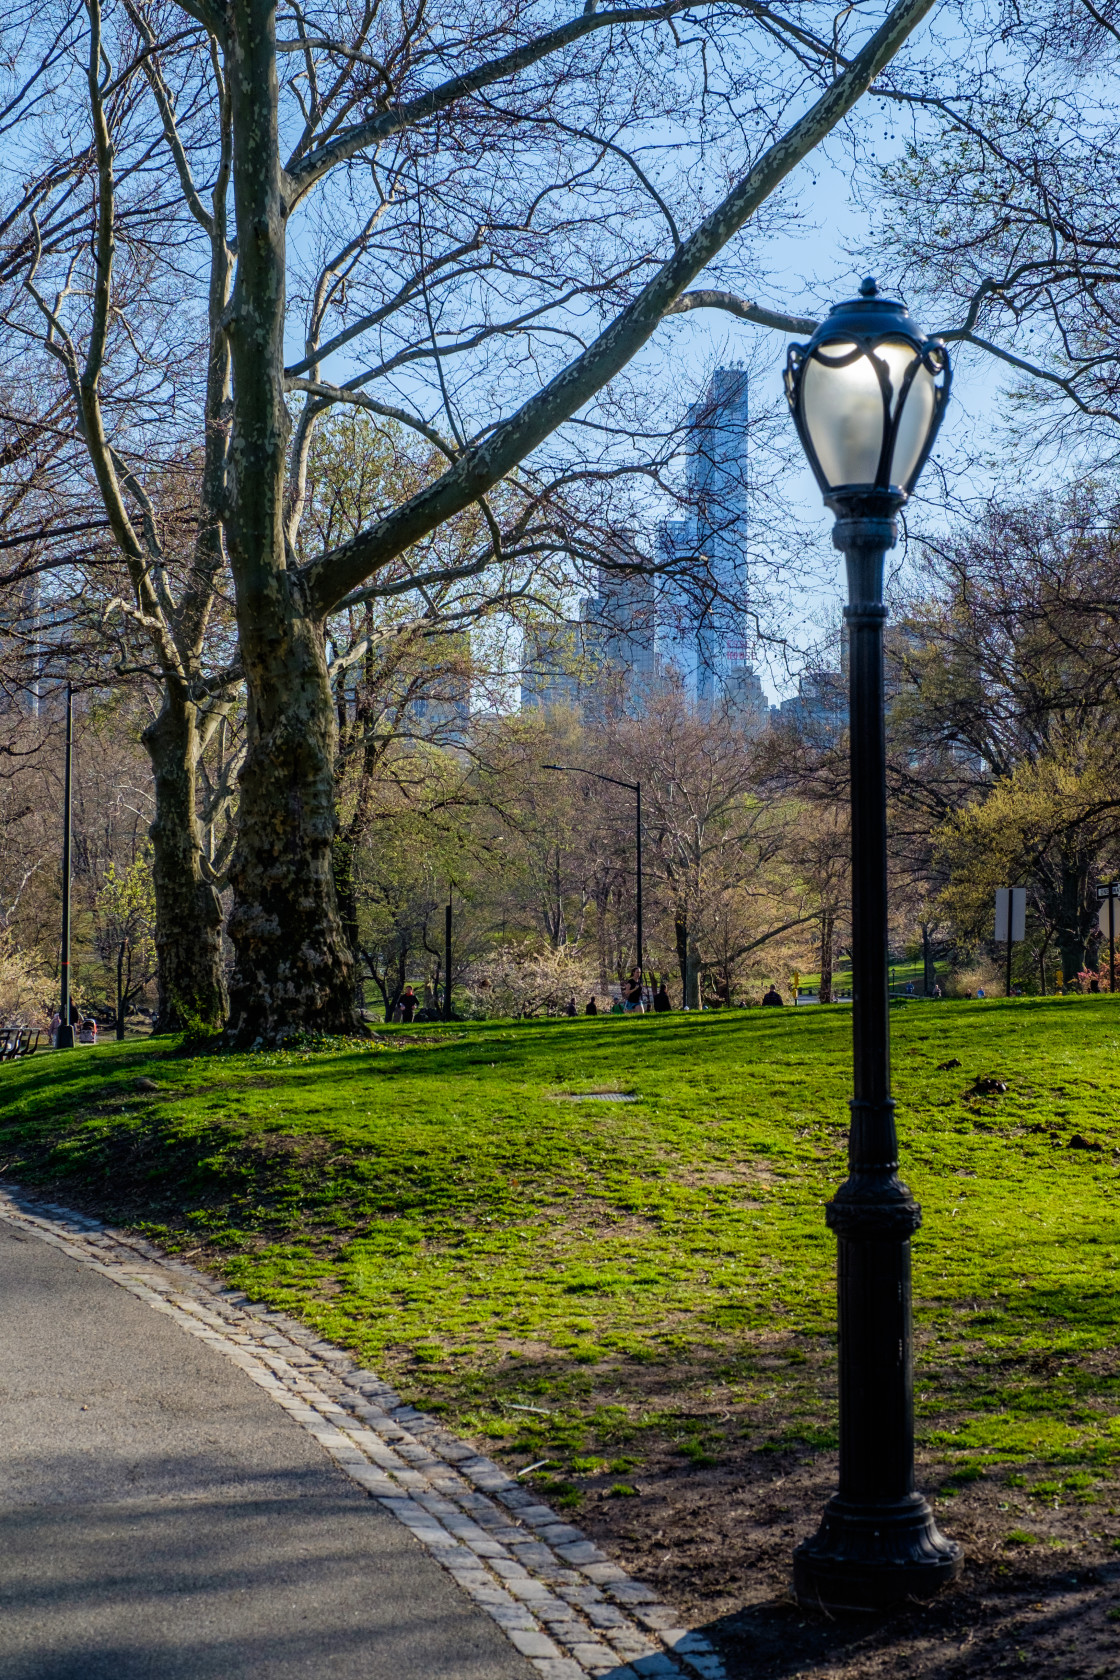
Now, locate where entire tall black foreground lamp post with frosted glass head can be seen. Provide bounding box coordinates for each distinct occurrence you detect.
[786,279,962,1611]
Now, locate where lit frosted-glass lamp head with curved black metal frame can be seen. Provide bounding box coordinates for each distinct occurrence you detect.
[786,277,952,501]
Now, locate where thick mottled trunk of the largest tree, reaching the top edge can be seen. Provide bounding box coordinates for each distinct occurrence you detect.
[225,0,359,1043]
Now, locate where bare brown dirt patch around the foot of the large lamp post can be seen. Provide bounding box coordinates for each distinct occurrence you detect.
[578,1441,1120,1680]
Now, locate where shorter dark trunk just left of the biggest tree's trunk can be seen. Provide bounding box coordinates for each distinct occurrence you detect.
[143,689,225,1033]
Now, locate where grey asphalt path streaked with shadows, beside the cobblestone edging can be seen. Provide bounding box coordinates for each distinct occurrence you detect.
[0,1221,537,1680]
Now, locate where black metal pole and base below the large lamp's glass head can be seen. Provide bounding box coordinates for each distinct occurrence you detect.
[794,492,962,1609]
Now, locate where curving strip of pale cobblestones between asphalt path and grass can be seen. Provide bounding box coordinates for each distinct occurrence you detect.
[0,1184,724,1680]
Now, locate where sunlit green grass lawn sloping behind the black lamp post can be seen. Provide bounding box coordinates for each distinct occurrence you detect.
[0,996,1120,1505]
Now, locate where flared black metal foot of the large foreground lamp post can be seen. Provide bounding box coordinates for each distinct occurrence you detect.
[793,1494,964,1611]
